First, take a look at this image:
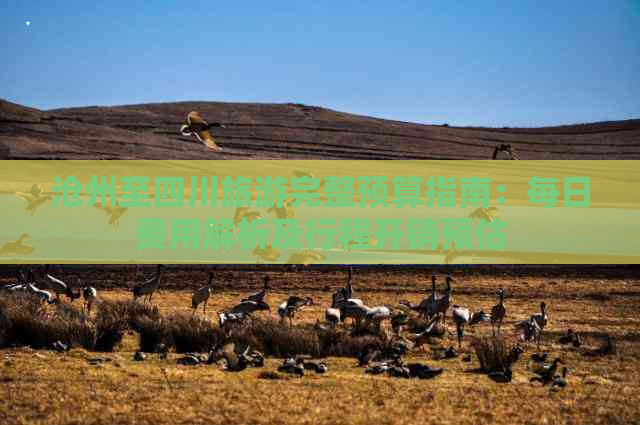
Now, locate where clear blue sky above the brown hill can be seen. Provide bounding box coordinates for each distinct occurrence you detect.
[0,0,640,126]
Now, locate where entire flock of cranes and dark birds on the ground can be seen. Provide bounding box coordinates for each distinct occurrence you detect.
[3,265,582,388]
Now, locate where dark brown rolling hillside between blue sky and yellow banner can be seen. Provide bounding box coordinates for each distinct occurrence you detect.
[0,100,640,159]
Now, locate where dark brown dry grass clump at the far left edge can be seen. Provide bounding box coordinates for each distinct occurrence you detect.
[0,293,95,349]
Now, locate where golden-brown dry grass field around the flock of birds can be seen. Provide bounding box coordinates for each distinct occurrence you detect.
[0,266,640,425]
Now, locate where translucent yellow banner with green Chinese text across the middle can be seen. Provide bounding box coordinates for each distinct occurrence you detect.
[0,160,640,264]
